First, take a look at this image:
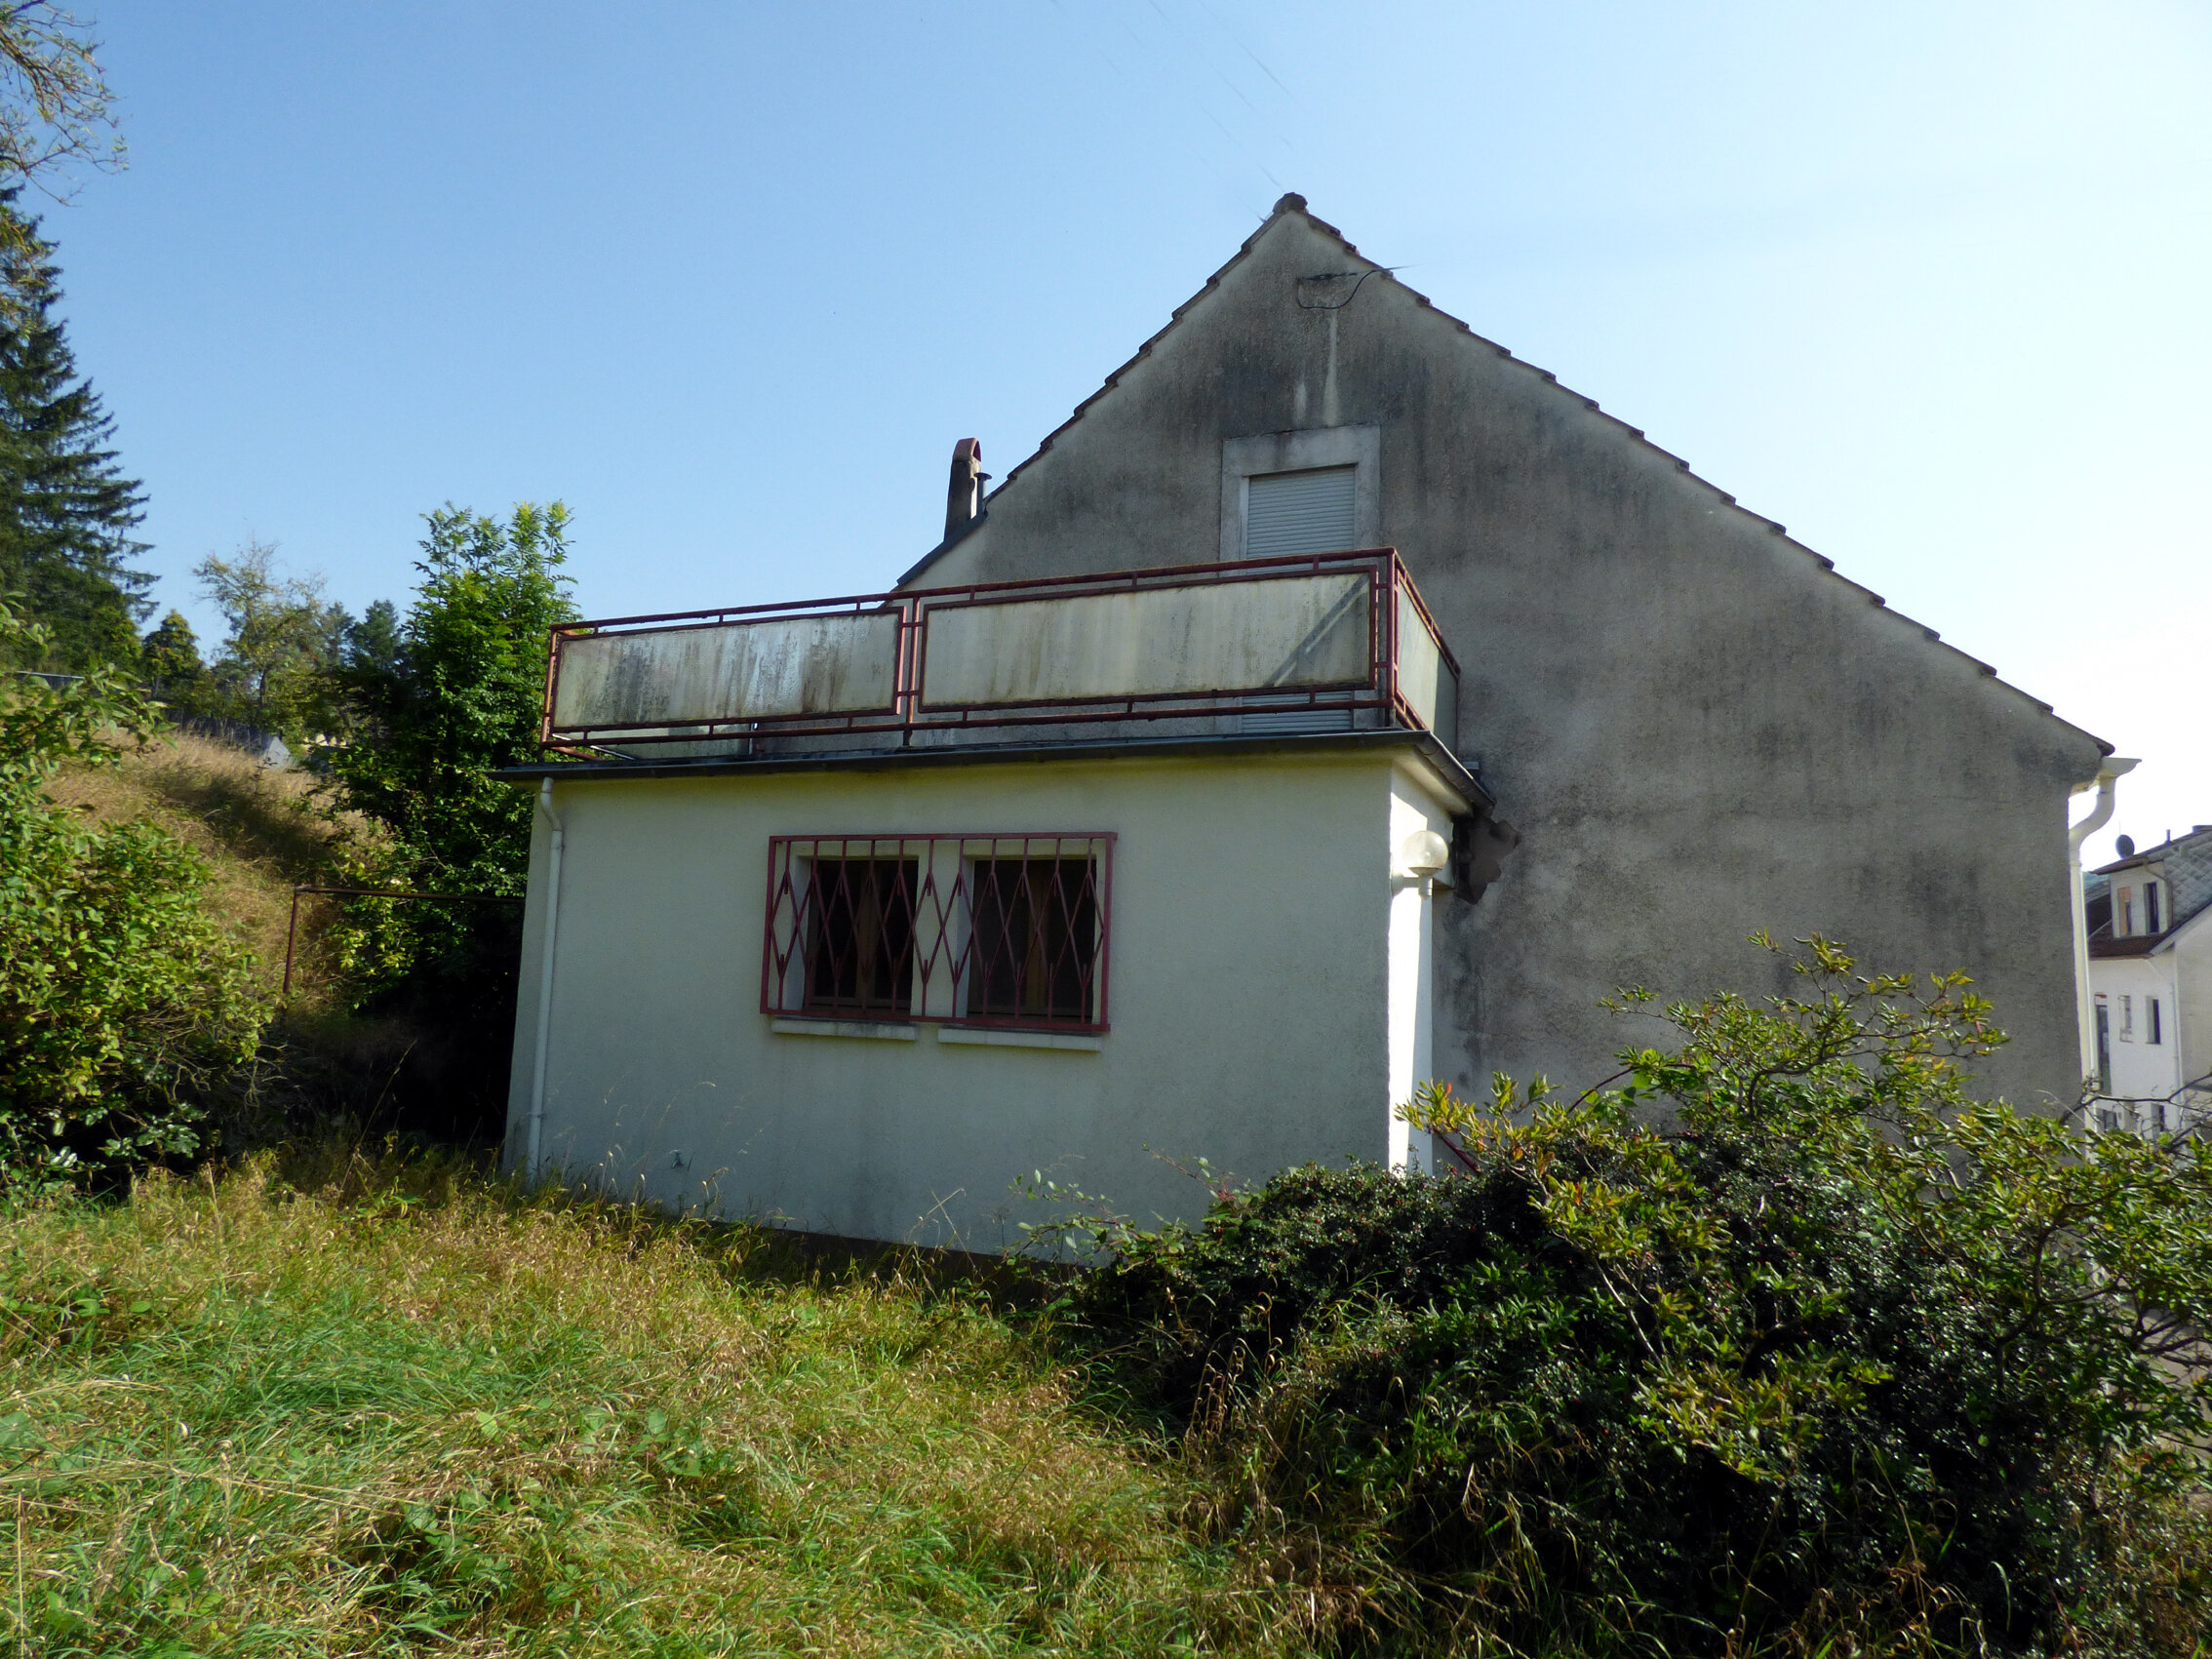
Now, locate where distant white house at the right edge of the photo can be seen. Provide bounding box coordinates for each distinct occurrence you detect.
[2081,823,2212,1134]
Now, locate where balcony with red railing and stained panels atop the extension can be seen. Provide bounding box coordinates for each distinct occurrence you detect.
[542,548,1460,759]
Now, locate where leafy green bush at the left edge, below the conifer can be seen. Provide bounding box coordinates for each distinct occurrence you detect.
[0,606,263,1183]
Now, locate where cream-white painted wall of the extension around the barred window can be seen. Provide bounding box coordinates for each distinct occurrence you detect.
[511,750,1451,1249]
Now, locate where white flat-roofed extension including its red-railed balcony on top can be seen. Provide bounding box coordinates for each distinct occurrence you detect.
[509,551,1511,1249]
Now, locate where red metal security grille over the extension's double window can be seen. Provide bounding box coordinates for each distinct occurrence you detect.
[761,832,1115,1031]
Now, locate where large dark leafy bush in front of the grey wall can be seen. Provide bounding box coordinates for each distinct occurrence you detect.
[1073,940,2212,1654]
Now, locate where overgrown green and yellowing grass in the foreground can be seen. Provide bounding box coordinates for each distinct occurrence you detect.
[0,1157,1303,1659]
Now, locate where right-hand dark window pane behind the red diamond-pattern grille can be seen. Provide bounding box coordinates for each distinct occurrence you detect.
[968,858,1099,1024]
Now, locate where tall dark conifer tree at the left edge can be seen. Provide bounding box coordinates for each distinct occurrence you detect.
[0,190,152,668]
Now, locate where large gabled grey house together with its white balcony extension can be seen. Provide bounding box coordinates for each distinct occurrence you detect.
[509,197,2111,1247]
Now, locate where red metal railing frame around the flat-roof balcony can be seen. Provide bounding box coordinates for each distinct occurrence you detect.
[539,548,1460,750]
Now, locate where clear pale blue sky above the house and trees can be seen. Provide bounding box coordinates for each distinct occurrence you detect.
[34,0,2212,871]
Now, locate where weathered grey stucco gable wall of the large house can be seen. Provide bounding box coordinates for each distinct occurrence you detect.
[911,210,2099,1119]
